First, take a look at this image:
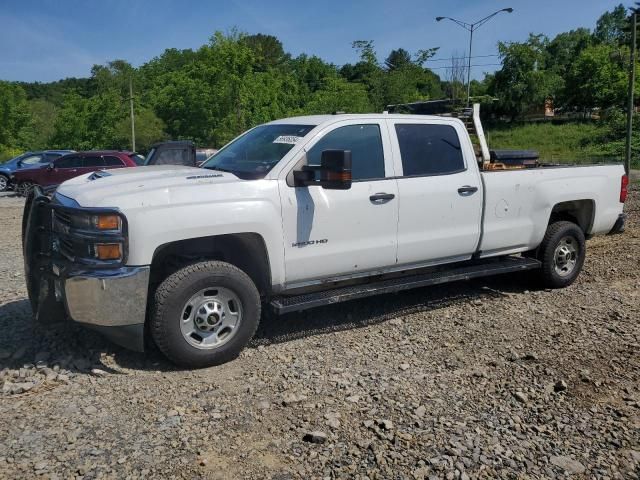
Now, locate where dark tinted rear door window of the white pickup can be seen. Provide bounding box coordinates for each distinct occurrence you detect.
[396,123,465,177]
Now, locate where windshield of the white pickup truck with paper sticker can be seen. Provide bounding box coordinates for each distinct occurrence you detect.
[202,124,315,180]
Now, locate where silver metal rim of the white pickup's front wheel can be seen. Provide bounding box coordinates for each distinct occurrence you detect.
[180,287,242,350]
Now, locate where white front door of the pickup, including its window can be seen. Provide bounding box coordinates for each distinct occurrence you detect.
[280,120,398,287]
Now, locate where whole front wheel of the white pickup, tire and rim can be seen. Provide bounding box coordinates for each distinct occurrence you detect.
[150,261,260,368]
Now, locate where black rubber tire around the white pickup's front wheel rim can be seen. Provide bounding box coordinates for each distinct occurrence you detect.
[149,261,261,368]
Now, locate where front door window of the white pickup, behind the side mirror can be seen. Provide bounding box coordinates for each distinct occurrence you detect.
[307,124,385,181]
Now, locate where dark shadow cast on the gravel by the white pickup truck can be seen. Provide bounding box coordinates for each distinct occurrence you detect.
[0,273,535,378]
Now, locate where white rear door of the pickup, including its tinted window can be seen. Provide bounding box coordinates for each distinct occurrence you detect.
[389,120,482,265]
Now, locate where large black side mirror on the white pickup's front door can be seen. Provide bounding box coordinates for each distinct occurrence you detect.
[293,150,351,190]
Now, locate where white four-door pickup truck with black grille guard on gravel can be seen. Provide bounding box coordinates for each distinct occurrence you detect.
[23,114,627,367]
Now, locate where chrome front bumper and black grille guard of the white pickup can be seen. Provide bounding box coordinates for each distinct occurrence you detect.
[23,189,150,351]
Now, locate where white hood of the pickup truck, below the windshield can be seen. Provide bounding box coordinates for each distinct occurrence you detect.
[56,165,243,208]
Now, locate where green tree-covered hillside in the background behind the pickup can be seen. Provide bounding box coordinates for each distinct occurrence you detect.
[0,5,640,165]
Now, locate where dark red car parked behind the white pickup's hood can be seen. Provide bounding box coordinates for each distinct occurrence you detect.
[12,150,137,196]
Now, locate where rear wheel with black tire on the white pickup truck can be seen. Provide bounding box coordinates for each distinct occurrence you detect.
[538,221,586,288]
